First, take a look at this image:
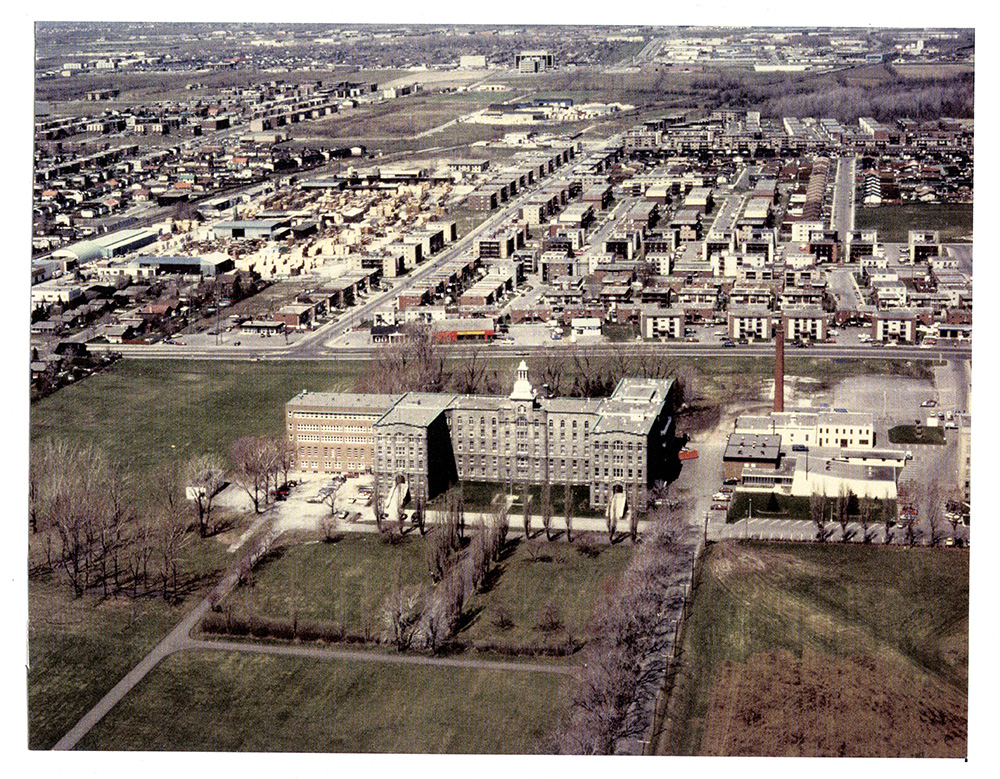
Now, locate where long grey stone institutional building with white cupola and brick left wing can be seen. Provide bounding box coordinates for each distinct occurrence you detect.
[285,362,676,507]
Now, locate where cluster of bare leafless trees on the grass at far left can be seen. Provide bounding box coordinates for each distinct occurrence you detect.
[28,437,291,601]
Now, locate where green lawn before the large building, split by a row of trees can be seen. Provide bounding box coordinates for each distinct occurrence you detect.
[213,532,633,645]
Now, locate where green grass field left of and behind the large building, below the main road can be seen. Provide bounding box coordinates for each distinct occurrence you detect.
[31,359,368,474]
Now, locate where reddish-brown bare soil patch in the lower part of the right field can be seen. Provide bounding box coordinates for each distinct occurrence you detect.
[700,650,968,758]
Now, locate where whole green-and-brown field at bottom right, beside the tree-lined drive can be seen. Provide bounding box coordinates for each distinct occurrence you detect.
[657,542,969,757]
